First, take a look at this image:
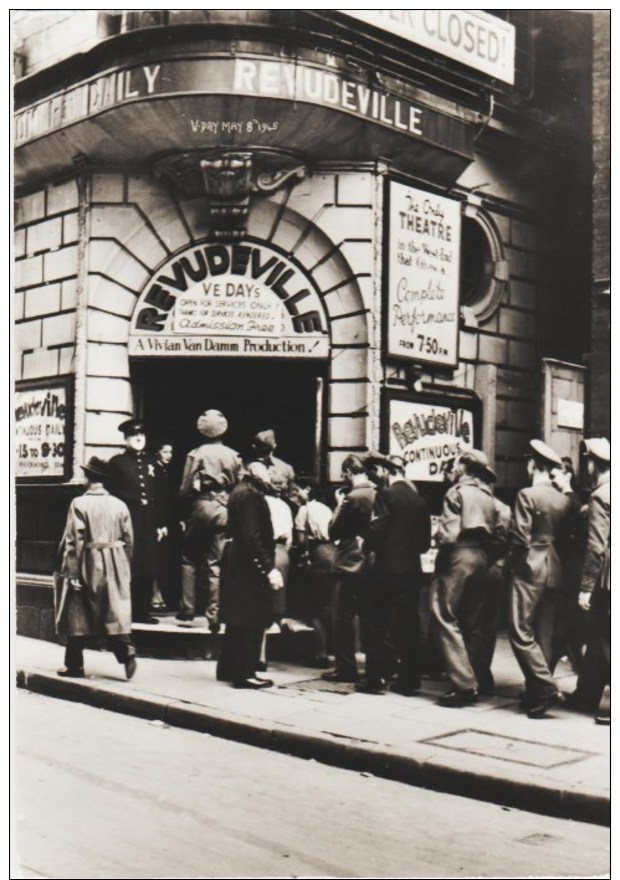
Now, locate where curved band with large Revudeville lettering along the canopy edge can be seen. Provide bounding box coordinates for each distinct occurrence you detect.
[15,57,471,151]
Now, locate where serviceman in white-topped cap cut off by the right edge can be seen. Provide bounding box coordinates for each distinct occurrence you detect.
[569,437,611,724]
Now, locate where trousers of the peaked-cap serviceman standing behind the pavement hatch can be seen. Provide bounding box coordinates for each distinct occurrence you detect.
[510,574,561,700]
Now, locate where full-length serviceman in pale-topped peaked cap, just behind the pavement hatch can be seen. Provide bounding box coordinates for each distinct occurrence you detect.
[509,440,570,718]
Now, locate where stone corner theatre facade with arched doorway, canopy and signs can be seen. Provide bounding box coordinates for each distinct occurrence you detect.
[13,10,591,582]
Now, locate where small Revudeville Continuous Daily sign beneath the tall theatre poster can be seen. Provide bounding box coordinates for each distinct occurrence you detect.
[388,398,474,482]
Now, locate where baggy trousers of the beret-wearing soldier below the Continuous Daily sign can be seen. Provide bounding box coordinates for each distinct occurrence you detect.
[431,544,488,691]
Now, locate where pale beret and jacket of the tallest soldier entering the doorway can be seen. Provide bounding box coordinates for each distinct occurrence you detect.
[181,409,243,500]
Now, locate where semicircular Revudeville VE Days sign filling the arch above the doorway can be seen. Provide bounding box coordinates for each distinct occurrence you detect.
[129,240,329,358]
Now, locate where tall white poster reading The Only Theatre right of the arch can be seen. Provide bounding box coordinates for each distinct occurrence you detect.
[387,181,461,366]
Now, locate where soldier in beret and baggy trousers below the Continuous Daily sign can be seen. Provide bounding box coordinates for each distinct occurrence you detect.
[431,449,496,707]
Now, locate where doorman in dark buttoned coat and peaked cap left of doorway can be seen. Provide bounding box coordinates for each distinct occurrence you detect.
[106,419,167,624]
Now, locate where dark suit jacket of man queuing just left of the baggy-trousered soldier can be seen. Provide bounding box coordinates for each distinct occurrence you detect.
[366,480,431,576]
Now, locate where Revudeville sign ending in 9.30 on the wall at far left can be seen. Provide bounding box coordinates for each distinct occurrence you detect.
[15,386,67,478]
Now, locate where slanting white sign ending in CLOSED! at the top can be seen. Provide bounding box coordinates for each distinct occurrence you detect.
[338,9,515,85]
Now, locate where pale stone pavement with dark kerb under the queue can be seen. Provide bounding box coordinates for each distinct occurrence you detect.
[13,636,611,825]
